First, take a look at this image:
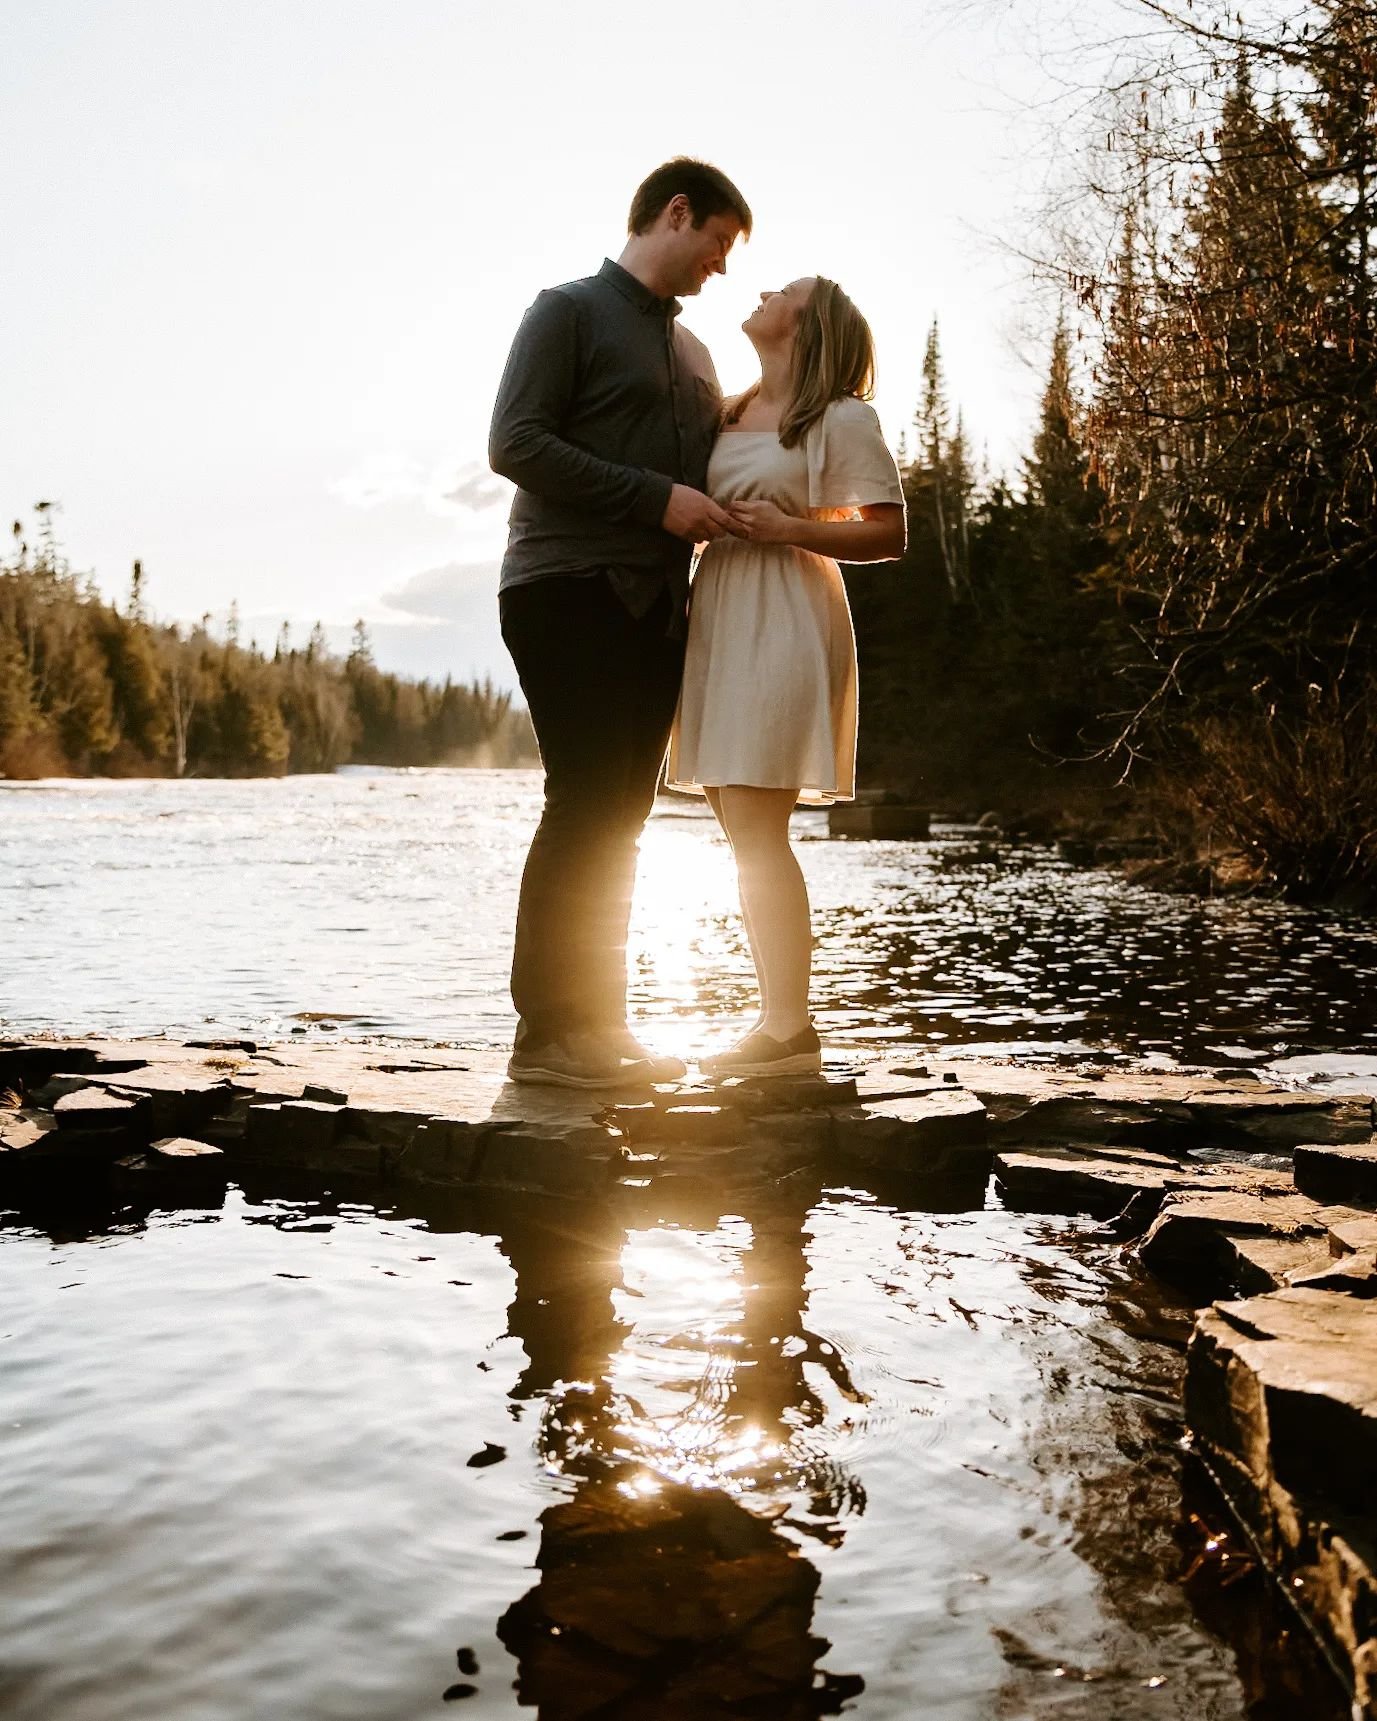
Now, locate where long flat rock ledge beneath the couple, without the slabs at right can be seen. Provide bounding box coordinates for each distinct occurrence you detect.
[0,1039,993,1194]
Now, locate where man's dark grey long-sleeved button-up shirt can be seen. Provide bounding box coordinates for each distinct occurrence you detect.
[489,249,721,614]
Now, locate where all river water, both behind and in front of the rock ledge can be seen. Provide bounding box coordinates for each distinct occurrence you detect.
[0,771,1377,1721]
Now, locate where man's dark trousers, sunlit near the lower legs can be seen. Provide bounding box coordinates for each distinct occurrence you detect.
[501,573,683,1046]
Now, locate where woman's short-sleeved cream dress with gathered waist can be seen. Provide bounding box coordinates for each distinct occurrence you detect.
[666,398,904,804]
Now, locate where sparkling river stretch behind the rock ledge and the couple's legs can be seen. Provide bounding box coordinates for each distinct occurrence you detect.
[0,771,1377,1062]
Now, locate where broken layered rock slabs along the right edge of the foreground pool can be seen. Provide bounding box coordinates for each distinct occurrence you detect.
[993,1079,1377,1718]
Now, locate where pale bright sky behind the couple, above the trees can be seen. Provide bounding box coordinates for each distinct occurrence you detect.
[0,0,1080,680]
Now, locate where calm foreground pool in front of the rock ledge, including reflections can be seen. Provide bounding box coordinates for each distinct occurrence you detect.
[0,1179,1336,1721]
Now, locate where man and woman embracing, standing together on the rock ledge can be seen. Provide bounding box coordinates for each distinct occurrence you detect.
[491,160,904,1088]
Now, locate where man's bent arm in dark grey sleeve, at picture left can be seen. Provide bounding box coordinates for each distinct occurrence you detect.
[487,287,675,527]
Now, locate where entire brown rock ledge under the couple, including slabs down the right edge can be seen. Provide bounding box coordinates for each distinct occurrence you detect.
[0,1038,1377,1721]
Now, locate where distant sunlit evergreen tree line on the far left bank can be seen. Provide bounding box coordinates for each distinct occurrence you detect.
[0,503,537,778]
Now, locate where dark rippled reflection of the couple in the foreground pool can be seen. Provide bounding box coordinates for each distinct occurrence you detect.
[497,1187,862,1721]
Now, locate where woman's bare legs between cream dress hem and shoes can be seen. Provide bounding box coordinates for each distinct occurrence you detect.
[713,783,812,1039]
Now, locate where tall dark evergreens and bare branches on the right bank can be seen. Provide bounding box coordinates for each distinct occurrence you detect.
[847,0,1377,904]
